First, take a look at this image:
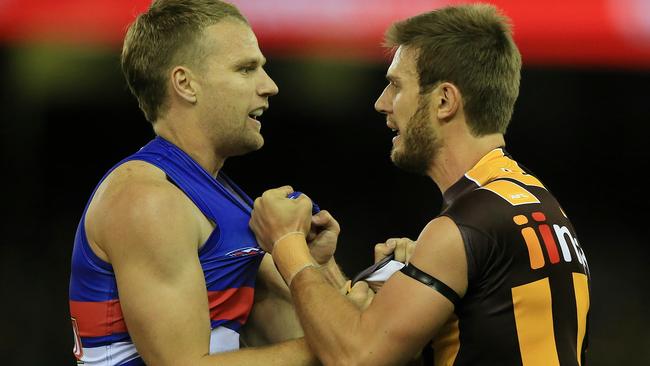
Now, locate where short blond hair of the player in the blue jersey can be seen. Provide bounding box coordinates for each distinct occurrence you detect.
[121,0,248,123]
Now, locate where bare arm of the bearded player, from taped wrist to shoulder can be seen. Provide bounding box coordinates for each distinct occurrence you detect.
[268,217,467,365]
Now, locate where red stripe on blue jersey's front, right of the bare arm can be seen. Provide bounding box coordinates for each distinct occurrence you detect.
[208,287,255,324]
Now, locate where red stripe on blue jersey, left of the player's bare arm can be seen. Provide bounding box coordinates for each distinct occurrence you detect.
[70,300,126,337]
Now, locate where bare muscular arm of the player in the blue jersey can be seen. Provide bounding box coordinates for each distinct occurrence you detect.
[88,172,316,366]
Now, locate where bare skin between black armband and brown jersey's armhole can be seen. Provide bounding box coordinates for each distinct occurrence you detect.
[410,216,467,296]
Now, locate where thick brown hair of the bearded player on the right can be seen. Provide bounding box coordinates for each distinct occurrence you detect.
[385,4,521,136]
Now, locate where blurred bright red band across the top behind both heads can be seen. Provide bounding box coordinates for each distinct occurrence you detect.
[0,0,650,68]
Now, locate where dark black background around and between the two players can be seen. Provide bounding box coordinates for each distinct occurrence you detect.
[0,44,650,365]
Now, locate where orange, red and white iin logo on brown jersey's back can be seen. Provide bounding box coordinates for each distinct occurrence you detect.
[512,211,587,269]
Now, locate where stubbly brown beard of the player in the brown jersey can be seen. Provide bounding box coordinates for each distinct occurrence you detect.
[391,96,442,175]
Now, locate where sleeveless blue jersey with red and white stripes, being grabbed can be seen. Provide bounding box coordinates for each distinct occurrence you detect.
[70,137,264,366]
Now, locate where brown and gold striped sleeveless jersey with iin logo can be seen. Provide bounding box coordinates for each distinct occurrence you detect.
[432,148,590,366]
